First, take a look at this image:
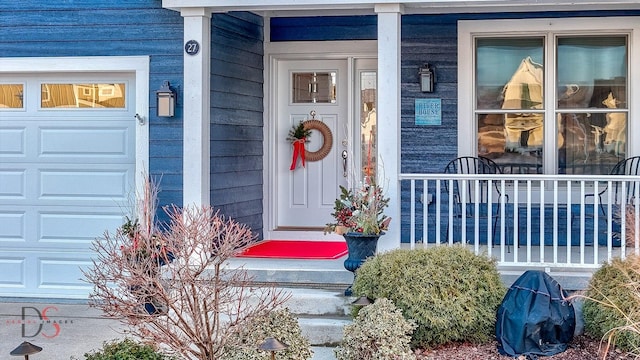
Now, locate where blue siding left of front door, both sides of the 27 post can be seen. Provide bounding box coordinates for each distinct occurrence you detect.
[0,0,263,233]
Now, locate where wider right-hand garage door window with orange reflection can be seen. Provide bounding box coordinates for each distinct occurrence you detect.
[40,84,125,108]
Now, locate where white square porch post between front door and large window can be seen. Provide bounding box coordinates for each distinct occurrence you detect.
[375,4,404,251]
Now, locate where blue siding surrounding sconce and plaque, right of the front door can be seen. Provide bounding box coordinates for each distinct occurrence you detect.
[401,11,640,242]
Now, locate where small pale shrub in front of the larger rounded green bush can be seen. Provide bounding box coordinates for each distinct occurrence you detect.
[335,298,416,360]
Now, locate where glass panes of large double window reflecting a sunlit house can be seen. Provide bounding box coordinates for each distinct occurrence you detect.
[475,35,629,174]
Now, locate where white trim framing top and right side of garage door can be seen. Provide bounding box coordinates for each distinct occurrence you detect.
[0,56,149,205]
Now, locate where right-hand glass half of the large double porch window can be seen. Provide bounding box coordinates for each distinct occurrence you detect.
[556,36,627,174]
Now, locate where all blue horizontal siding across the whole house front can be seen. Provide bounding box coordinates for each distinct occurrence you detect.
[6,0,640,242]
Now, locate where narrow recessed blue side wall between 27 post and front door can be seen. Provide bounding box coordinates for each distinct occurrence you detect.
[211,13,264,237]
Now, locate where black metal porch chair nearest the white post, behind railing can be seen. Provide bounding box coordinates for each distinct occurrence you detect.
[444,156,509,244]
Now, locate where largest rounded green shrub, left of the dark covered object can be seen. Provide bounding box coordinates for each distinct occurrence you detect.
[353,246,506,348]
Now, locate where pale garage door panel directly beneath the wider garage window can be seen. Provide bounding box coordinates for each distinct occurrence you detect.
[38,127,133,161]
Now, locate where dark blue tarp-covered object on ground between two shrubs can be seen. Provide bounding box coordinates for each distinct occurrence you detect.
[496,270,576,356]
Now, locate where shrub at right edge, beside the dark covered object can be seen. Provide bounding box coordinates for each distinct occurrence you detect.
[583,256,640,352]
